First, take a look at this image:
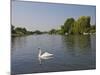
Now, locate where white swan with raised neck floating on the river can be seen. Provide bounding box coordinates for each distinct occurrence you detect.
[38,48,53,64]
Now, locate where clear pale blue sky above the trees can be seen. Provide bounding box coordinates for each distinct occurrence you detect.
[11,1,96,31]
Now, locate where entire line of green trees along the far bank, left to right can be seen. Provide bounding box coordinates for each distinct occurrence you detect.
[11,16,96,36]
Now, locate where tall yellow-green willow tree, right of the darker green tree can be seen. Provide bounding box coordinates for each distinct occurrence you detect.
[73,16,90,34]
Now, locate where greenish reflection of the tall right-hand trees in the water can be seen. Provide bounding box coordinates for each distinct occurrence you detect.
[62,35,91,54]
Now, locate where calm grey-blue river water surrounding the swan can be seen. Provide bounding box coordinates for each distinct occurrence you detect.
[11,34,96,75]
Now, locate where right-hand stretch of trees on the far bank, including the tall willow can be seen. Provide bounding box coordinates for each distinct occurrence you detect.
[49,16,96,34]
